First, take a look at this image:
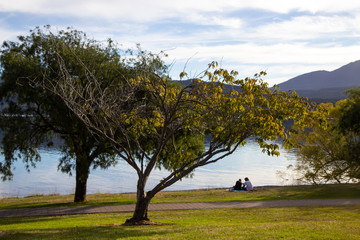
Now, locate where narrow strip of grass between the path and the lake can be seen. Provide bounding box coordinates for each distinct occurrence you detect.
[0,184,360,209]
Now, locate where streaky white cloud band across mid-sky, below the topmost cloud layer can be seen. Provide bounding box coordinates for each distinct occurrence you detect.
[83,12,360,49]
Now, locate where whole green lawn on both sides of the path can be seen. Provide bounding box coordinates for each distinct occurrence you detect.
[0,184,360,240]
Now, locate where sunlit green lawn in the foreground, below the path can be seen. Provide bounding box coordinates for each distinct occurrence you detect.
[0,206,360,240]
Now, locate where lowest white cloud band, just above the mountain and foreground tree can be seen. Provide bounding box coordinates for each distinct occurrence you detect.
[165,44,360,84]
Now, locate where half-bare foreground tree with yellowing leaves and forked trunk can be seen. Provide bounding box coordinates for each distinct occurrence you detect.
[34,41,315,224]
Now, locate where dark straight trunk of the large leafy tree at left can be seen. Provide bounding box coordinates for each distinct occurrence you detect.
[74,156,90,202]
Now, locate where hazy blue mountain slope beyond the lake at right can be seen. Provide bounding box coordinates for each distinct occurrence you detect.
[279,60,360,102]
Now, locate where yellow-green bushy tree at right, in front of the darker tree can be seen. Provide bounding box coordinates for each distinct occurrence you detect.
[284,101,360,184]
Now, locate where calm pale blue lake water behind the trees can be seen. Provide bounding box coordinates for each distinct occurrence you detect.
[0,141,295,198]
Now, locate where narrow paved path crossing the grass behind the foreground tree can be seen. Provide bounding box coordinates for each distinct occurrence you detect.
[0,199,360,217]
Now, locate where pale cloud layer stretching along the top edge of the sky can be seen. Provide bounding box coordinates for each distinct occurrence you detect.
[0,0,360,22]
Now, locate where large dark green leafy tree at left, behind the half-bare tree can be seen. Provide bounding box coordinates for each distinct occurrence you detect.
[0,26,195,202]
